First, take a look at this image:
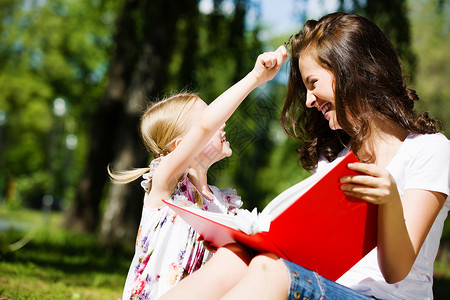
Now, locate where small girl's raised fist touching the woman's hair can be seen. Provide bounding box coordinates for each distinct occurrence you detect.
[252,46,288,84]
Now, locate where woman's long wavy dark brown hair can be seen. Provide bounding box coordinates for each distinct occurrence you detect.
[281,13,442,169]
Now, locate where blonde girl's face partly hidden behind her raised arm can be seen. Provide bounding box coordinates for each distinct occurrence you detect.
[191,99,232,165]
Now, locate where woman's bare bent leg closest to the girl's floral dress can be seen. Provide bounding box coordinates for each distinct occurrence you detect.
[160,244,251,300]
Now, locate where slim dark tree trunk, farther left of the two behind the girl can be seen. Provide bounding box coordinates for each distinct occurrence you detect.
[65,0,140,232]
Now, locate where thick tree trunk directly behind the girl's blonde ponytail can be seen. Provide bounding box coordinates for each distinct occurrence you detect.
[100,0,198,245]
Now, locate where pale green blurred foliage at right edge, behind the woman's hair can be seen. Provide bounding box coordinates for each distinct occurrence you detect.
[409,0,450,135]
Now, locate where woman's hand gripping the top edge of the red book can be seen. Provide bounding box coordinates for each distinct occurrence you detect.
[340,163,400,205]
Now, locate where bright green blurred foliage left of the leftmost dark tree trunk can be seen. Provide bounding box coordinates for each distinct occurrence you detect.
[0,0,116,206]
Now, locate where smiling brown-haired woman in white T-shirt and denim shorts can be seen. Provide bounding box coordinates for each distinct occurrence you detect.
[160,13,450,299]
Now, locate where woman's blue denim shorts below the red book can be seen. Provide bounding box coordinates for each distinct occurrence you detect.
[283,259,374,300]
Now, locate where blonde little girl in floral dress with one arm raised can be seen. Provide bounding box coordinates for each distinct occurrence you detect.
[110,47,287,299]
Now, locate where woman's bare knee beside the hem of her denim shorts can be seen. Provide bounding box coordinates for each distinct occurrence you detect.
[222,254,289,300]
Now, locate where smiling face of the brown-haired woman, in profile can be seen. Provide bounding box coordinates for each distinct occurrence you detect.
[298,53,341,130]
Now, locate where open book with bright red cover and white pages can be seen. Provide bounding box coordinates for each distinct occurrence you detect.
[164,151,377,280]
